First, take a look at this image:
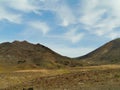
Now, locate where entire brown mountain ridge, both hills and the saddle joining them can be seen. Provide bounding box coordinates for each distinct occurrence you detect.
[0,38,120,70]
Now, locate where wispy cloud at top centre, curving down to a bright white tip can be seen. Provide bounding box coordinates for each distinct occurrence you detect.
[35,0,76,27]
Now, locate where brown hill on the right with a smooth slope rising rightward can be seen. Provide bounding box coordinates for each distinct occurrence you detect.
[76,38,120,65]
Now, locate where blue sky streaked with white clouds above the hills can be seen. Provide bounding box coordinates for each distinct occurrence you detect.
[0,0,120,57]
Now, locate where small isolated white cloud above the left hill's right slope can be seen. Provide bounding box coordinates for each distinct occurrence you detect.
[28,21,50,35]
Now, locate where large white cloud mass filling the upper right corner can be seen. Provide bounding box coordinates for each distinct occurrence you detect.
[80,0,120,38]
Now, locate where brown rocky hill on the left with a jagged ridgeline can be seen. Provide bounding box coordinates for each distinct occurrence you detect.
[0,41,79,69]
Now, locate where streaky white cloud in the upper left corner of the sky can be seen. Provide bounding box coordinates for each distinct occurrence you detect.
[0,0,39,23]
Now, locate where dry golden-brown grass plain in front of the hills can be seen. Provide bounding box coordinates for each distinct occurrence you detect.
[0,65,120,90]
